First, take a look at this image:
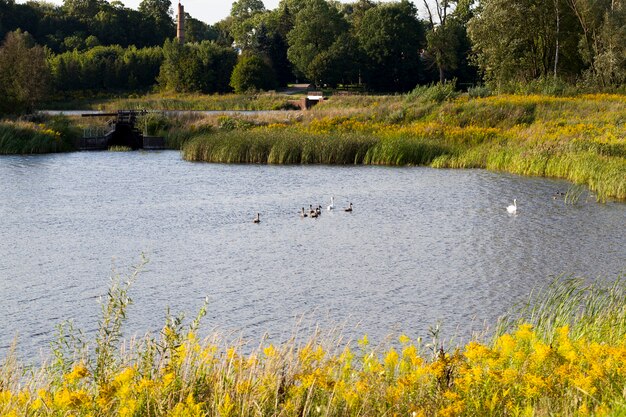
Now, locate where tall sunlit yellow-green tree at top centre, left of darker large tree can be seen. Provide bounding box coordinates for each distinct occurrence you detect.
[287,0,348,83]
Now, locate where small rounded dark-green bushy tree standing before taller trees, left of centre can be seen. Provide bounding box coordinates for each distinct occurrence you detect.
[230,55,276,94]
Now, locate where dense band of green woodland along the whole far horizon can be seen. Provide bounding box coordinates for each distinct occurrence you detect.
[0,0,626,113]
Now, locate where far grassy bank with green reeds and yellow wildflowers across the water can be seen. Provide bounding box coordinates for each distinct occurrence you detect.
[182,95,626,200]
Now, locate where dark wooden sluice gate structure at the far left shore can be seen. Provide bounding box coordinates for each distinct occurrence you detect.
[76,110,165,151]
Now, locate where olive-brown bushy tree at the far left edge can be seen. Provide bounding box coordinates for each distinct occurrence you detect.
[0,30,50,114]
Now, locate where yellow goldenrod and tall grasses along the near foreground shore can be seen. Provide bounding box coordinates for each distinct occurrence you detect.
[0,258,626,417]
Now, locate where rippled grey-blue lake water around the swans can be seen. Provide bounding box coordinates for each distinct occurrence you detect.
[0,151,626,358]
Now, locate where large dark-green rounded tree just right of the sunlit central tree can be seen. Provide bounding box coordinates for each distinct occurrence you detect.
[356,0,425,91]
